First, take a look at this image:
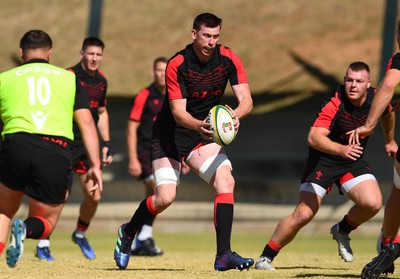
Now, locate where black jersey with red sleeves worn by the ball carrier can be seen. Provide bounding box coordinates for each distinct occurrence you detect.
[153,44,248,158]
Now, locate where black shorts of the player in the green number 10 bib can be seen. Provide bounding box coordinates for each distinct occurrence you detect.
[0,133,71,204]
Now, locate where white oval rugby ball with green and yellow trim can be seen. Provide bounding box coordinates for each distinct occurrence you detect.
[208,105,236,146]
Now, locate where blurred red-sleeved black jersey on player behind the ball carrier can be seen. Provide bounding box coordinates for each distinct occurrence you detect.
[129,82,165,150]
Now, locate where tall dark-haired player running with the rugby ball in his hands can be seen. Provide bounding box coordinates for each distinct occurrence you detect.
[114,13,254,271]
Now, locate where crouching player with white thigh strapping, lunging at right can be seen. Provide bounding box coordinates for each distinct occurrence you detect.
[255,62,397,270]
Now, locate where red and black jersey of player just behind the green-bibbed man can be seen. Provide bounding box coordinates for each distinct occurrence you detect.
[68,63,107,142]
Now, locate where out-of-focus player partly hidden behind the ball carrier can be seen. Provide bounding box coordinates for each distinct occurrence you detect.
[127,57,168,256]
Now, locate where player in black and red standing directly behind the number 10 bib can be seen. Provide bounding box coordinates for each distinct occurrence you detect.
[36,37,114,261]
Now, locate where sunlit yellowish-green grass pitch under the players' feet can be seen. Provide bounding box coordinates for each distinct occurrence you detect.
[0,232,394,279]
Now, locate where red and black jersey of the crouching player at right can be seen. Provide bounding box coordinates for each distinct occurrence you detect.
[309,85,389,161]
